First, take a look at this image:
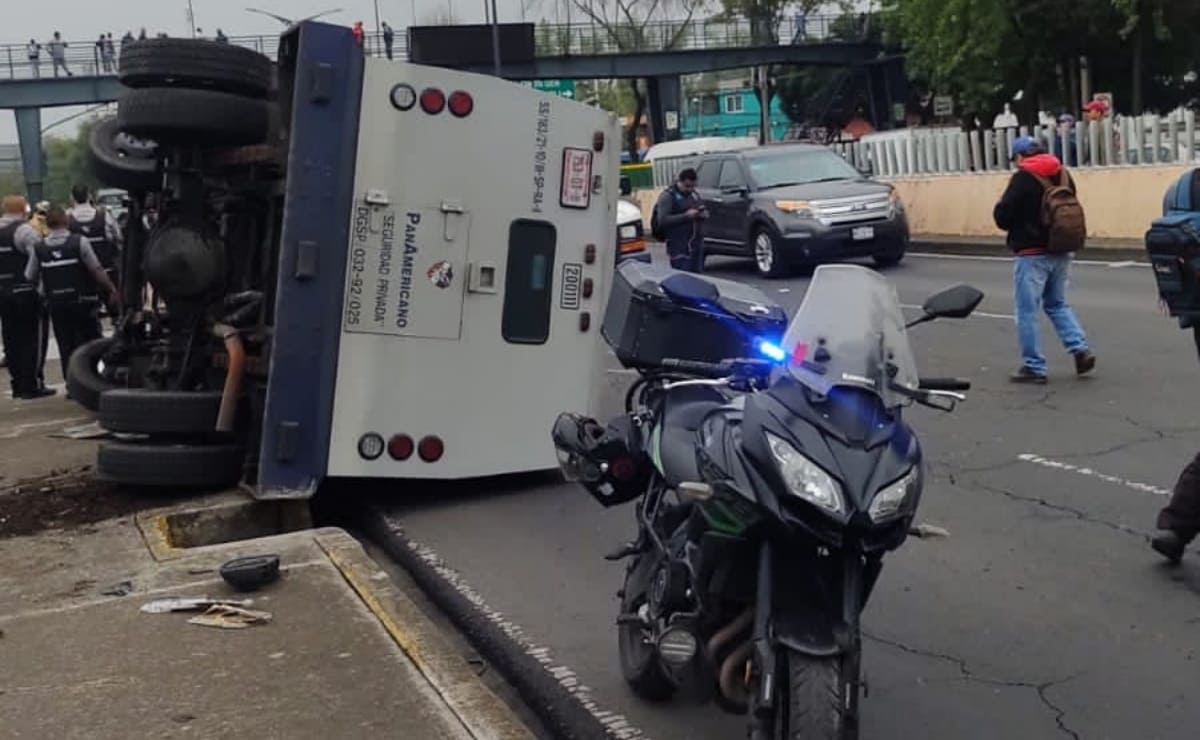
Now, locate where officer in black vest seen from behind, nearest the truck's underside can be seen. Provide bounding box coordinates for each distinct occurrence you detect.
[26,205,121,377]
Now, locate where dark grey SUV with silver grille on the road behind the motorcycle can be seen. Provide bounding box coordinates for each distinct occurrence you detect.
[696,144,908,277]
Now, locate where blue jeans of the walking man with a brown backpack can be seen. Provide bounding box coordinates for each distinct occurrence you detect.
[1014,254,1087,375]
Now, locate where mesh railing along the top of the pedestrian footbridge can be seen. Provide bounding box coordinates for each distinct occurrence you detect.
[0,16,846,79]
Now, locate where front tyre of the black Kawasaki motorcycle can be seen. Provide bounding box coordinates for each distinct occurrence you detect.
[775,650,858,740]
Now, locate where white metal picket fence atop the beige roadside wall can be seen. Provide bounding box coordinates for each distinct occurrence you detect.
[832,110,1198,178]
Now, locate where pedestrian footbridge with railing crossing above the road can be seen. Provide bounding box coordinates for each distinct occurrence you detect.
[0,16,906,199]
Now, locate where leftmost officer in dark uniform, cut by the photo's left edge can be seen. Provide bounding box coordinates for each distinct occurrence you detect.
[0,195,54,399]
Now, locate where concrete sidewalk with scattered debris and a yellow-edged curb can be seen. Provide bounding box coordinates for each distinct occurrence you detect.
[0,494,534,740]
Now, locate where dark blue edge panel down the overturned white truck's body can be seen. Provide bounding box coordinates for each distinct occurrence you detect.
[257,23,362,498]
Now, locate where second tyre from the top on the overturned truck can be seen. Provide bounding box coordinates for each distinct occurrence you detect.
[116,88,270,146]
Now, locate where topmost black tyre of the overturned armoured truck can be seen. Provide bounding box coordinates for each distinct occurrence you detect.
[120,38,272,97]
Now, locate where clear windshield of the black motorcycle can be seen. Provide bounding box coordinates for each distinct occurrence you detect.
[782,265,919,408]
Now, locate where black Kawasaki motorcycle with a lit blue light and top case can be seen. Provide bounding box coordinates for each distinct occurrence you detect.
[552,265,983,740]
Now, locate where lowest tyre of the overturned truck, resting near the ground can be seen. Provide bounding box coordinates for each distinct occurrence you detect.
[96,441,246,488]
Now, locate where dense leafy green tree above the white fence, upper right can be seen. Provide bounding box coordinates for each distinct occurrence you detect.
[884,0,1200,120]
